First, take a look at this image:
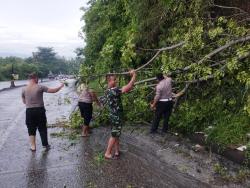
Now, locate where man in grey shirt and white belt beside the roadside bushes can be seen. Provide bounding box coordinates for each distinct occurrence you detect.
[150,73,173,133]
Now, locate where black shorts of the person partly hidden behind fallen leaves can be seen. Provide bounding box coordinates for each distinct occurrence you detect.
[78,102,93,126]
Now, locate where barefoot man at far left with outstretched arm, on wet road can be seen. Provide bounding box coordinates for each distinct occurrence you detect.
[22,73,64,151]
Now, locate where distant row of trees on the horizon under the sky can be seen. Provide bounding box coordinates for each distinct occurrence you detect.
[0,47,81,81]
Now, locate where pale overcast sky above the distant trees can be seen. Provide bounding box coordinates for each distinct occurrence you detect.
[0,0,88,58]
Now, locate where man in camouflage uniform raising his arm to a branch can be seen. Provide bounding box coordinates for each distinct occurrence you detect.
[104,70,136,159]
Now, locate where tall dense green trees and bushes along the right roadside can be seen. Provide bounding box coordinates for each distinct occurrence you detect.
[79,0,250,151]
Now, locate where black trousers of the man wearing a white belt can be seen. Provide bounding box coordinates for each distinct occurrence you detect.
[151,101,173,132]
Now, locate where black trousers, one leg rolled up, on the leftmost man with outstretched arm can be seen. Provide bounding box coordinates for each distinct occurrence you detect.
[26,107,48,146]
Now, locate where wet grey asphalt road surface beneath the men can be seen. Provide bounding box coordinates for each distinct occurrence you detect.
[0,81,209,188]
